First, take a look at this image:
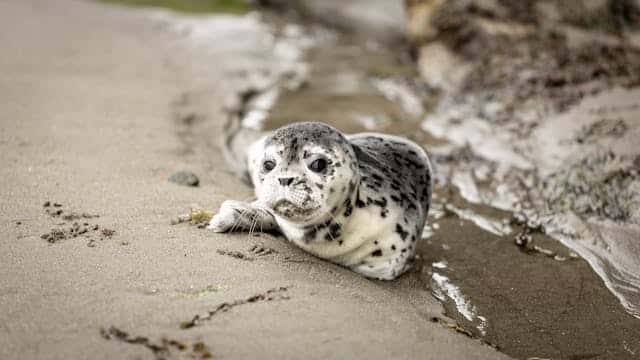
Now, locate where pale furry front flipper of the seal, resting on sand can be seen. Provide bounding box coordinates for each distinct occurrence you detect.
[207,200,278,232]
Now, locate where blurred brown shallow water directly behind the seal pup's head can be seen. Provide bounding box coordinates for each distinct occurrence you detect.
[264,38,424,133]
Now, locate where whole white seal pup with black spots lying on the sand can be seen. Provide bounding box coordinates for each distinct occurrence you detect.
[208,122,431,280]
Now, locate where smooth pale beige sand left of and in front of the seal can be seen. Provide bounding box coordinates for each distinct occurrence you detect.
[0,0,505,359]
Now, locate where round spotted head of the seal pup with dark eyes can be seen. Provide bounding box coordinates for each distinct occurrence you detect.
[249,123,359,226]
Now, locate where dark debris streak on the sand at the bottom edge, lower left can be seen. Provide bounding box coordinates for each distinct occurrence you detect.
[100,326,212,360]
